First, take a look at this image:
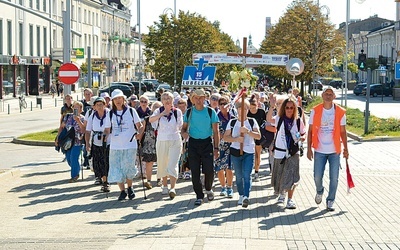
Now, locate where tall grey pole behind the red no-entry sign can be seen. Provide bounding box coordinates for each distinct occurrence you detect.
[62,0,71,95]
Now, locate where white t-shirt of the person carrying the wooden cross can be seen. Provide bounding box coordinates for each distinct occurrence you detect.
[226,118,260,154]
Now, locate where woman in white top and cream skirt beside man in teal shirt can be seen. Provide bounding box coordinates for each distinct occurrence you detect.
[149,92,183,199]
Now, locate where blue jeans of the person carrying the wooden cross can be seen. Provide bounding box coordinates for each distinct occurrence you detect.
[231,152,254,197]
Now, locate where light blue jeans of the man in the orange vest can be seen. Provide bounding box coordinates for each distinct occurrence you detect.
[314,152,340,201]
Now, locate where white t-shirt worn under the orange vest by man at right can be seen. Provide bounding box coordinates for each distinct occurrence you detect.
[308,105,346,154]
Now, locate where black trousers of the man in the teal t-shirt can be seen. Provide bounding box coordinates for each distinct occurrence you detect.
[188,137,214,199]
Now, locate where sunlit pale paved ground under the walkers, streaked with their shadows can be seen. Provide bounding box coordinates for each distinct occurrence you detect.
[0,140,400,250]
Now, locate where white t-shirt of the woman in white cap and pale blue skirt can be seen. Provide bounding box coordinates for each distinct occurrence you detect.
[105,107,140,149]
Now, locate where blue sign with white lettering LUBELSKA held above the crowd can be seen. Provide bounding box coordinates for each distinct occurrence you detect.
[182,58,216,87]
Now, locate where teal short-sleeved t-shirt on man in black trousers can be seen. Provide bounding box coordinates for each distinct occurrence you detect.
[183,106,219,139]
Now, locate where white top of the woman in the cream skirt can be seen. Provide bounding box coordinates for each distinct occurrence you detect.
[151,108,183,141]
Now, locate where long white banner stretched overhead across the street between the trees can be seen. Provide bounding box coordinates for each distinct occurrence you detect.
[193,53,289,66]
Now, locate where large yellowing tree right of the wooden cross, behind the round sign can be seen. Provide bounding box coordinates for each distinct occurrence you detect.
[259,0,345,90]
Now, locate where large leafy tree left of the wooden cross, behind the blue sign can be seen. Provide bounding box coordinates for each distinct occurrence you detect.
[143,11,237,89]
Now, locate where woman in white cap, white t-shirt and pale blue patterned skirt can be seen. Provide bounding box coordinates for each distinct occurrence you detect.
[106,89,142,200]
